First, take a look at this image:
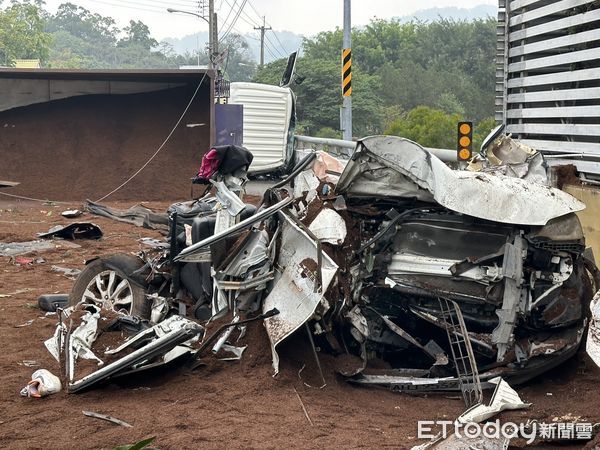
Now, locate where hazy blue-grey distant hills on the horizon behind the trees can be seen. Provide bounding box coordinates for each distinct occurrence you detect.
[163,5,498,63]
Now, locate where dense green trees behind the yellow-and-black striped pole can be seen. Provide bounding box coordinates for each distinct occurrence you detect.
[255,19,496,141]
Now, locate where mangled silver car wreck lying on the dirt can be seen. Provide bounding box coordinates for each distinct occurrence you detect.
[58,136,599,394]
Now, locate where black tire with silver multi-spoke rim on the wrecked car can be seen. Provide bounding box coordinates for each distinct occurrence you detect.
[69,255,151,319]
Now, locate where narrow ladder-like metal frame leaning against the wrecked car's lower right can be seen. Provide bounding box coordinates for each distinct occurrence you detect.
[438,297,483,408]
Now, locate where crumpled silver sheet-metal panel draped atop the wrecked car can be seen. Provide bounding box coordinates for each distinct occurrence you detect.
[336,136,585,225]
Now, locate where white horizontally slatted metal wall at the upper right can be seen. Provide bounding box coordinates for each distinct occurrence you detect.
[496,0,600,173]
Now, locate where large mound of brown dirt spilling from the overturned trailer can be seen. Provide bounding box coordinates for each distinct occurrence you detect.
[0,86,210,201]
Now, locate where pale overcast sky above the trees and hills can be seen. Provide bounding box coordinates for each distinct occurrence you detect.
[39,0,497,40]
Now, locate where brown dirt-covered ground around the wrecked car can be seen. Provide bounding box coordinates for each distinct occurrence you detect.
[0,199,600,449]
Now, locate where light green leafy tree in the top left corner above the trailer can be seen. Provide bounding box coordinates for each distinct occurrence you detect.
[0,1,52,66]
